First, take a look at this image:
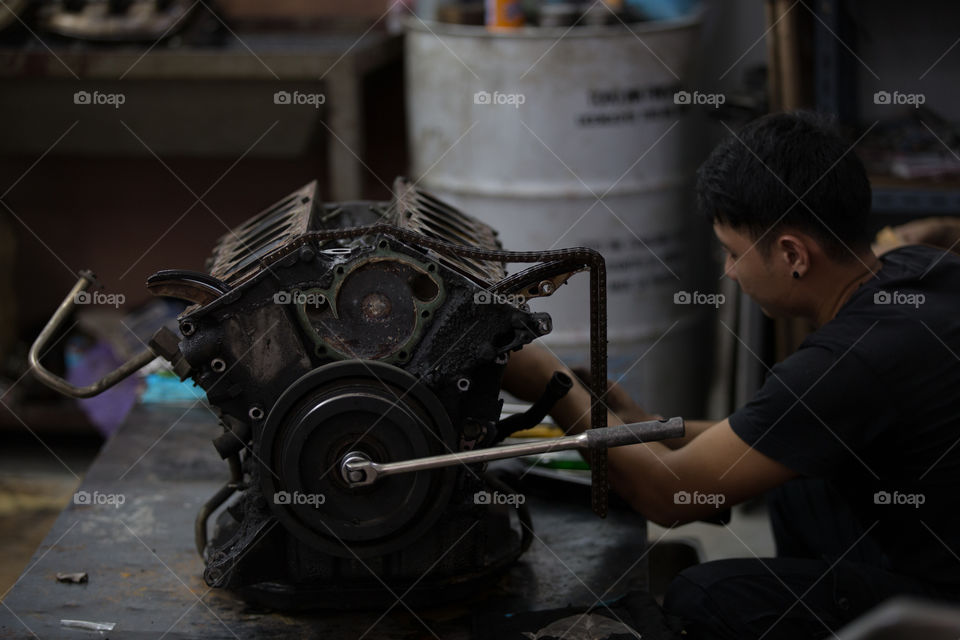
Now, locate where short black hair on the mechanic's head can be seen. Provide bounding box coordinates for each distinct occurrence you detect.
[697,112,870,261]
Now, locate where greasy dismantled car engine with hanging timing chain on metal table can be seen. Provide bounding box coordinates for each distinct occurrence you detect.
[31,178,682,609]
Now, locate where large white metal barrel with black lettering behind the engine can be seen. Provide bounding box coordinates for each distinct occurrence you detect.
[406,16,705,415]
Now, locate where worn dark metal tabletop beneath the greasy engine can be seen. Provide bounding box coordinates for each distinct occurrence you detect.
[0,406,647,640]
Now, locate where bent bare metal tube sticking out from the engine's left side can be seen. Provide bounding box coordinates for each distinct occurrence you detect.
[27,270,157,398]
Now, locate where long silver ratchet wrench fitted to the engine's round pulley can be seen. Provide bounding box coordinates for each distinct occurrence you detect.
[340,418,684,487]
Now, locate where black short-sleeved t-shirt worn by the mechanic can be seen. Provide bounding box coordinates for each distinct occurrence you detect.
[730,246,960,586]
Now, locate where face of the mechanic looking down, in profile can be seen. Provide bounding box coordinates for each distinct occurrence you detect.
[713,222,796,318]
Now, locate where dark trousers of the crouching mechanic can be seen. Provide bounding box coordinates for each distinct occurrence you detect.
[663,478,944,640]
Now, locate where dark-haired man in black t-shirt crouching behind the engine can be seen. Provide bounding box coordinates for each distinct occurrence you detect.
[504,113,960,640]
